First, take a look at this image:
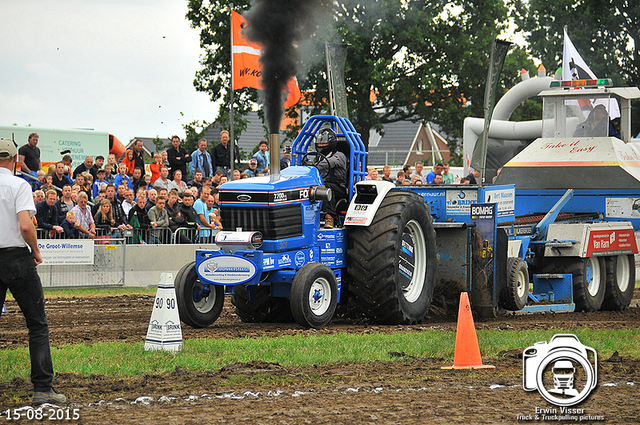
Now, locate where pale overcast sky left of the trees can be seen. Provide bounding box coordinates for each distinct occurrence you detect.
[0,0,217,144]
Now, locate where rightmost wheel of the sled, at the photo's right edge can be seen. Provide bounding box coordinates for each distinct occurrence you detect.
[602,255,636,310]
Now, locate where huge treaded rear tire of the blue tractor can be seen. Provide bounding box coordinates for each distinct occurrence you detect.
[347,191,436,324]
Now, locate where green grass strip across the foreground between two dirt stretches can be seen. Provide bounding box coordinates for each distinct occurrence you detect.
[0,329,640,382]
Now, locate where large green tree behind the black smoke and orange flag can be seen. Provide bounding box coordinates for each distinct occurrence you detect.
[187,0,539,156]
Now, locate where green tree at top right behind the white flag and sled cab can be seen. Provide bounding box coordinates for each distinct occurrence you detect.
[511,0,640,134]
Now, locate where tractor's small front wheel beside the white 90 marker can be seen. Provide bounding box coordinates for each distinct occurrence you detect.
[174,261,224,328]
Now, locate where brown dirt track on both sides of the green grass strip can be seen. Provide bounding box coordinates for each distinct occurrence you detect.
[0,291,640,424]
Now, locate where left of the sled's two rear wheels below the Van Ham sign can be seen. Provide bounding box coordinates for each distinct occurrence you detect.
[542,257,606,312]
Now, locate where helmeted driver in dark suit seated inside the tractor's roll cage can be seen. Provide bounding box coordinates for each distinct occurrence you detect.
[315,128,347,229]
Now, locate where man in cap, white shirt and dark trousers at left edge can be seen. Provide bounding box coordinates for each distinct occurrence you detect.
[0,138,67,405]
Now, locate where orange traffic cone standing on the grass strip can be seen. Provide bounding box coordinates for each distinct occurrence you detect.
[442,292,495,370]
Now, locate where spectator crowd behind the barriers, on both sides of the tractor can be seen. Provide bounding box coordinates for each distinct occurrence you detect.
[18,131,479,243]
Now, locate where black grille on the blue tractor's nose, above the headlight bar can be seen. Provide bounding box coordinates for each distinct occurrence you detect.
[220,204,302,240]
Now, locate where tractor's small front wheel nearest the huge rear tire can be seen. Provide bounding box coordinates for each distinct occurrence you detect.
[290,263,338,329]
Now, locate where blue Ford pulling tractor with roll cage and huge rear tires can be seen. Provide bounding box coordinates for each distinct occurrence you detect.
[175,115,436,328]
